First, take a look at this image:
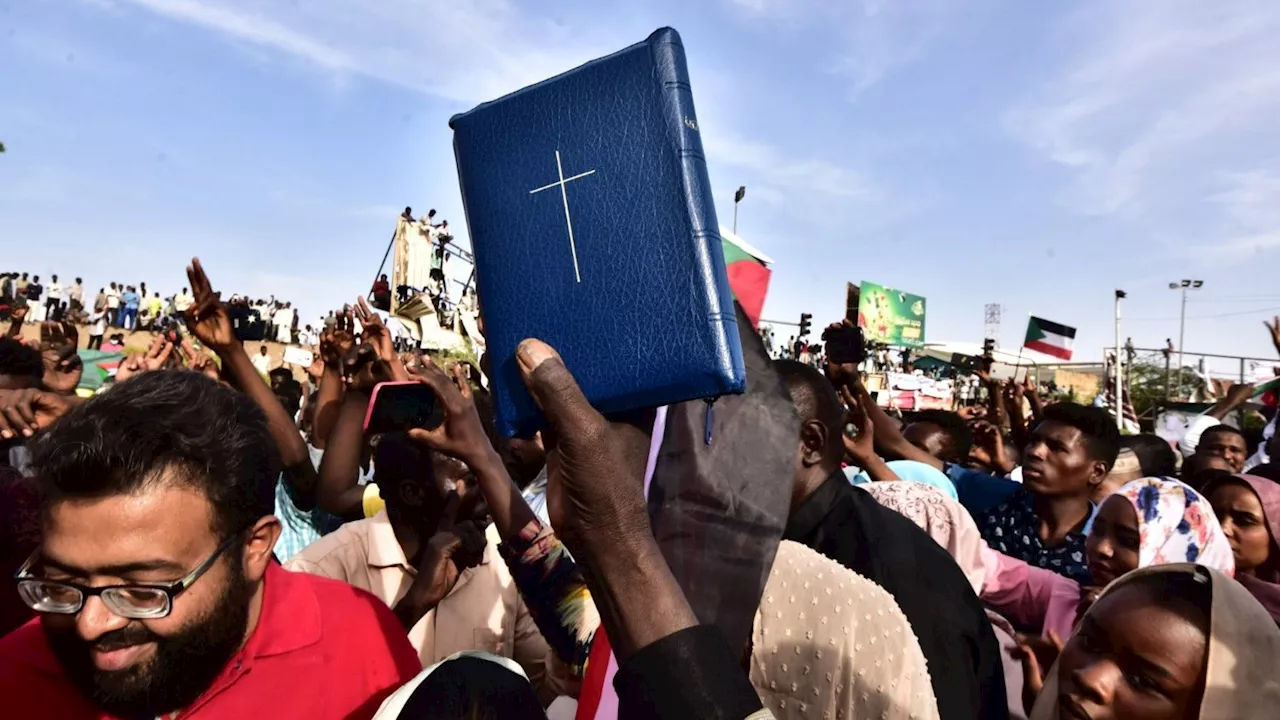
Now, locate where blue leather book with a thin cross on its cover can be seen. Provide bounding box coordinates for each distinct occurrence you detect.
[449,28,746,437]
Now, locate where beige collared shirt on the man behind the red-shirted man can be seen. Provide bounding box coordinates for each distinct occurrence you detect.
[284,510,558,697]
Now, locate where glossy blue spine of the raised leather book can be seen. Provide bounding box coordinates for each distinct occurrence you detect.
[649,28,746,392]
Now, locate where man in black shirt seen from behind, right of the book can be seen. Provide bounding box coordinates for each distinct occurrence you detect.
[774,360,1009,720]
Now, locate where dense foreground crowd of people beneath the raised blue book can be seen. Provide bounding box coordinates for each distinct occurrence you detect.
[0,258,1280,720]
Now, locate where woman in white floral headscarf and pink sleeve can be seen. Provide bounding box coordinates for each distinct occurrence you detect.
[982,478,1235,639]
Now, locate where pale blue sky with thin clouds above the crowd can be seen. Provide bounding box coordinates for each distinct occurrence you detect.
[0,0,1280,372]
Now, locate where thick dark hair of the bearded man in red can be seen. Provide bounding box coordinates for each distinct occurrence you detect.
[32,370,280,538]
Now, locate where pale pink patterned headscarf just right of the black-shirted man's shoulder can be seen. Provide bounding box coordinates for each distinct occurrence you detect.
[855,480,987,594]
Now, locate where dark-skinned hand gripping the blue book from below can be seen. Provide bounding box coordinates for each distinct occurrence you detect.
[516,340,653,564]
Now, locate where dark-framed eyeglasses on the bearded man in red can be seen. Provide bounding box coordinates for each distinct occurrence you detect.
[13,533,241,620]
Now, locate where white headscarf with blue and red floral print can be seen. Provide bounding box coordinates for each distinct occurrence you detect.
[1115,478,1235,577]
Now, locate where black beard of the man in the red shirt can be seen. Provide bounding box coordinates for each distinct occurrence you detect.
[44,562,253,717]
